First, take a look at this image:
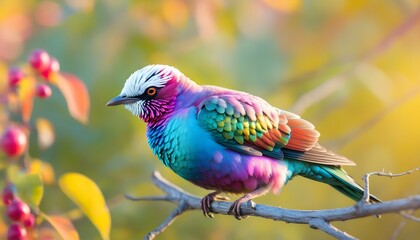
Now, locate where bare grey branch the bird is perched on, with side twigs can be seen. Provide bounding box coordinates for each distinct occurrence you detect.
[126,168,420,240]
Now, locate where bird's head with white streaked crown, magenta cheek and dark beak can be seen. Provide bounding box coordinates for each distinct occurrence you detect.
[106,65,184,122]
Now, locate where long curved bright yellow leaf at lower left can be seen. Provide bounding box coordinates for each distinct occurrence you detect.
[59,173,111,240]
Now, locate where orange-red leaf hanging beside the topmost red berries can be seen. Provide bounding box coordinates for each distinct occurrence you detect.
[54,73,90,123]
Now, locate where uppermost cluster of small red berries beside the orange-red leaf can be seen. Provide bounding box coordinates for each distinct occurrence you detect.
[8,49,60,98]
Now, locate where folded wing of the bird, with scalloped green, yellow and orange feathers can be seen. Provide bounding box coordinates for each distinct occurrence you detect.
[197,93,354,165]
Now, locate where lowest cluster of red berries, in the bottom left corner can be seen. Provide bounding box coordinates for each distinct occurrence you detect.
[2,184,35,240]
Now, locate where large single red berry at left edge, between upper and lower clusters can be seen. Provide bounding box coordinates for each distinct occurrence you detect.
[0,126,28,157]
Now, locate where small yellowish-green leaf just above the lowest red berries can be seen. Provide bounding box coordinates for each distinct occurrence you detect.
[12,173,44,209]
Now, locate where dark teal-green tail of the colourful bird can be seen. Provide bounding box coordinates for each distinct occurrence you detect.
[302,165,381,203]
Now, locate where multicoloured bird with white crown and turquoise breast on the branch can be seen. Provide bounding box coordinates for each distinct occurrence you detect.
[107,65,380,219]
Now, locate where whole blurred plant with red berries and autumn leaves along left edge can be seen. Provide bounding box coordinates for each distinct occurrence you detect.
[0,49,93,240]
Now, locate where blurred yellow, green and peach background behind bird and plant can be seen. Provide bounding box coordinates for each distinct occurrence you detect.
[0,0,420,239]
